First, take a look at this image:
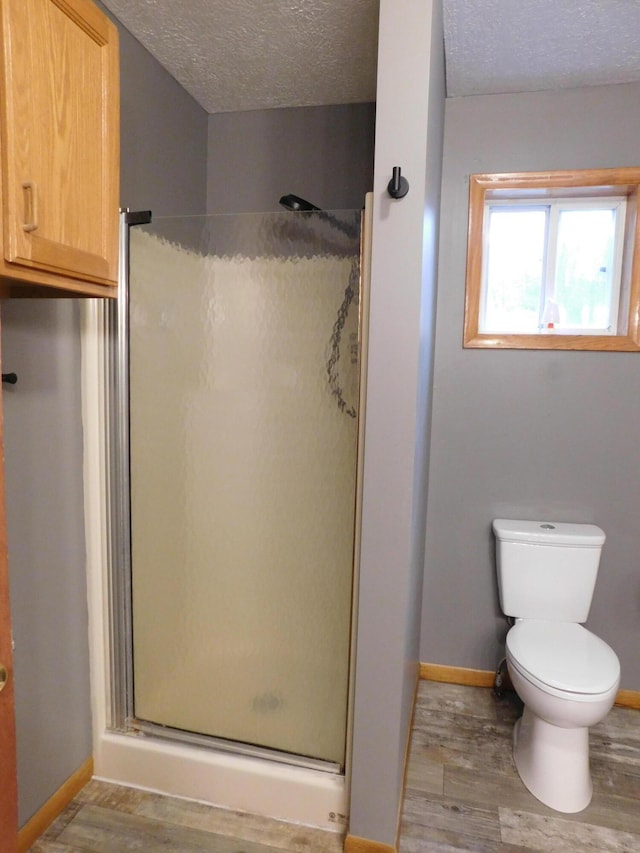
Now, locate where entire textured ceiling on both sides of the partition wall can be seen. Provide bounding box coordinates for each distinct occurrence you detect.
[102,0,640,113]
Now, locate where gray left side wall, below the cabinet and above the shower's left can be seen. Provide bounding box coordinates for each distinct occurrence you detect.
[2,8,207,825]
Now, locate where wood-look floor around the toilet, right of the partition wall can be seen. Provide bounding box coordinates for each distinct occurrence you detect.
[400,681,640,853]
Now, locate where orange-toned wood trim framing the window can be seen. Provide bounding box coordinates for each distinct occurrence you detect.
[463,168,640,352]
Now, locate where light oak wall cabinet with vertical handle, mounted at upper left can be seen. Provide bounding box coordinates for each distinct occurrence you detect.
[0,0,120,284]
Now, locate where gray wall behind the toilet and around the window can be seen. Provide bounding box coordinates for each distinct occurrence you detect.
[420,84,640,690]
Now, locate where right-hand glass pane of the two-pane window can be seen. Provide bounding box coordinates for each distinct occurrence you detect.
[555,208,616,329]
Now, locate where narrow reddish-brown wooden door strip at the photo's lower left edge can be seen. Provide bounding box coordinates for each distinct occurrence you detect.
[0,322,18,853]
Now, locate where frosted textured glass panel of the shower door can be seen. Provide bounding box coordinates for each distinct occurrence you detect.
[129,214,359,765]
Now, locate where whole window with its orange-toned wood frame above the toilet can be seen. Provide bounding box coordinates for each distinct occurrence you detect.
[464,169,640,350]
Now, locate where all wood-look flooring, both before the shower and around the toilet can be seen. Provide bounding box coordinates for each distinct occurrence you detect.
[31,681,640,853]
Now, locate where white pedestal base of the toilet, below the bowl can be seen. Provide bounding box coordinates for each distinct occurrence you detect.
[513,705,593,813]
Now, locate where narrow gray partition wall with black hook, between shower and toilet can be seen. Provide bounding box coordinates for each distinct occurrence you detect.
[349,0,444,845]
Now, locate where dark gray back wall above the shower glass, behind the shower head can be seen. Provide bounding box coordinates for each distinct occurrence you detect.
[207,104,375,213]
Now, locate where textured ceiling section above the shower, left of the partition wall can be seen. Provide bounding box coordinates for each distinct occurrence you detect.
[102,0,378,113]
